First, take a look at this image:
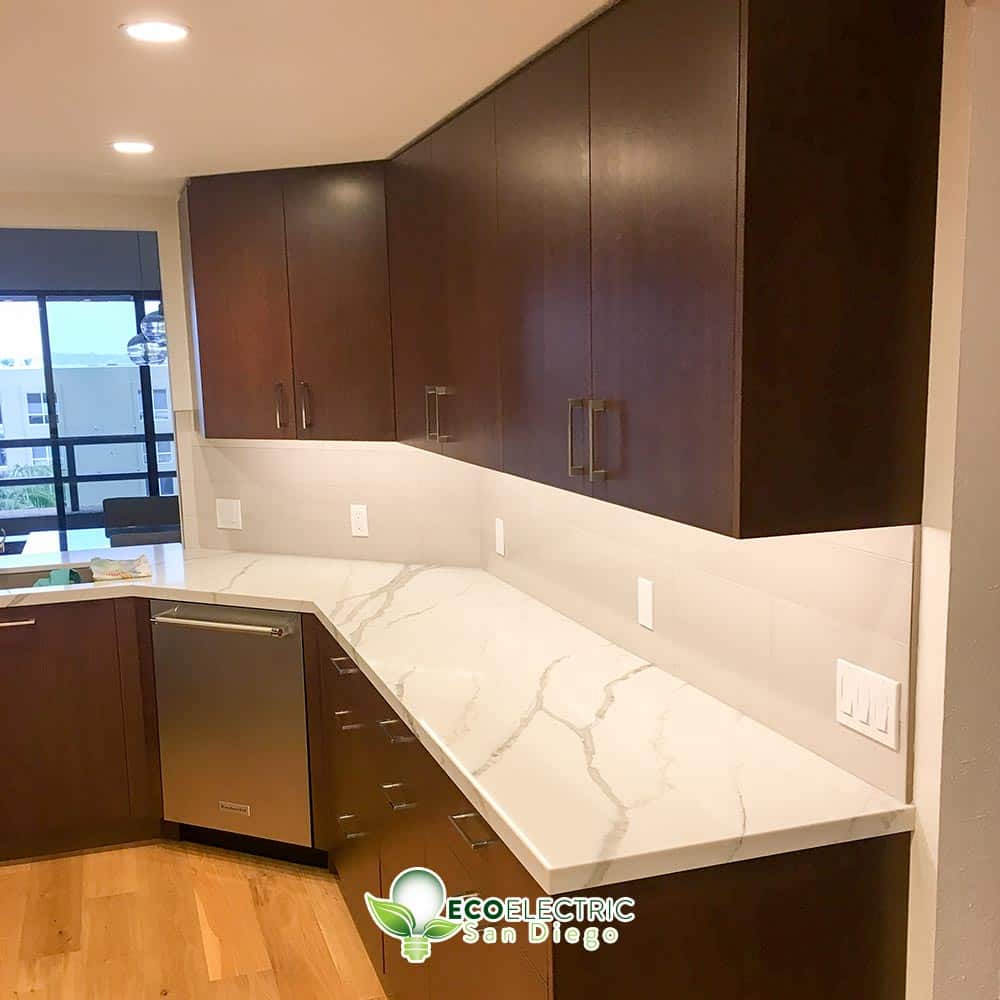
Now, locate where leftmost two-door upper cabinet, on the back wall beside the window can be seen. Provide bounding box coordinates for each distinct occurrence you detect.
[188,163,395,441]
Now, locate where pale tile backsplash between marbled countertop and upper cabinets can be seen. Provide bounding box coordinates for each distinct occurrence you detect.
[178,414,914,797]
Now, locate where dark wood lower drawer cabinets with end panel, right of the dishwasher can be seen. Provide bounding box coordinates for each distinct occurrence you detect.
[307,623,910,1000]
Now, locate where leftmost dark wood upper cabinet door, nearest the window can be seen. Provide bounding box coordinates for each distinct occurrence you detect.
[188,173,295,438]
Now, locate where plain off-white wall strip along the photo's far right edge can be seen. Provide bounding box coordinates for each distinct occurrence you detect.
[914,0,1000,1000]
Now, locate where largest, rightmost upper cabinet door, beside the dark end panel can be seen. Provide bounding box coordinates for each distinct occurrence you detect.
[590,0,740,532]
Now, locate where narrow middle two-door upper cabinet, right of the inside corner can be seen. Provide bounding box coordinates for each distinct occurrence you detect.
[388,98,501,468]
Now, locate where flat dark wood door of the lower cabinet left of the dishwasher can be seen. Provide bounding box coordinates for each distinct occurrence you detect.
[0,601,131,853]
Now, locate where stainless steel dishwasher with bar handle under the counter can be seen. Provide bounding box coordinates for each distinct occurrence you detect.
[150,601,312,847]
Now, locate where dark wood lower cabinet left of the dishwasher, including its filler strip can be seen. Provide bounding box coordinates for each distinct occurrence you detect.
[0,599,162,860]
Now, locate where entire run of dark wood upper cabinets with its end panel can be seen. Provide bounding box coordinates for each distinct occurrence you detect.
[189,0,944,537]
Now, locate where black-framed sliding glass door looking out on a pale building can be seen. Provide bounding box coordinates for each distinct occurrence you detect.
[0,292,177,548]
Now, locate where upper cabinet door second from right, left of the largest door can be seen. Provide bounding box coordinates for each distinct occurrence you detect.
[496,32,590,491]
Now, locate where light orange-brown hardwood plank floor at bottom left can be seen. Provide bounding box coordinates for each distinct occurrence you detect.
[0,843,384,1000]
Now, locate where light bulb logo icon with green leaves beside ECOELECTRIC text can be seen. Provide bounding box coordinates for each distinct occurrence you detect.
[365,868,462,965]
